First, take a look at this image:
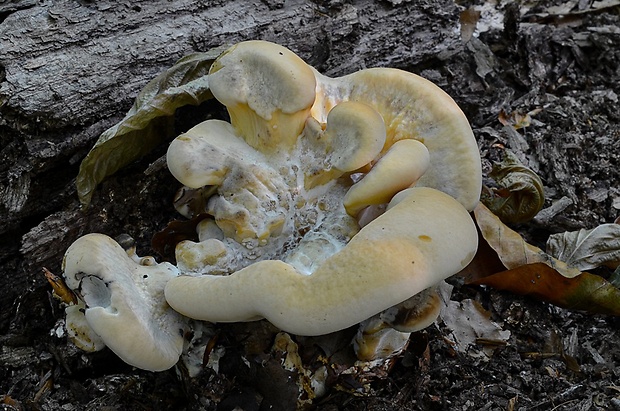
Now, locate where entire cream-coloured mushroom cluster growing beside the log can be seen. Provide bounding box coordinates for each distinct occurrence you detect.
[65,41,482,369]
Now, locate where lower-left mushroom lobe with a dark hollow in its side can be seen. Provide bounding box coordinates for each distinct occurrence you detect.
[63,234,186,371]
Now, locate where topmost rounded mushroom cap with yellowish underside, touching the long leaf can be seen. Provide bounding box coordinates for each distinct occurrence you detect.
[209,40,316,152]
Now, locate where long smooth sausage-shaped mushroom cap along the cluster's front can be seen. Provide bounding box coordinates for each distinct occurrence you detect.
[165,188,478,335]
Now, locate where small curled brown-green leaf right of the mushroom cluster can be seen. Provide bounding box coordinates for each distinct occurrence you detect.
[480,150,545,223]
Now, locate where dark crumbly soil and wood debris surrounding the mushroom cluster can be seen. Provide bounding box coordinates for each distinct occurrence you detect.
[0,1,620,411]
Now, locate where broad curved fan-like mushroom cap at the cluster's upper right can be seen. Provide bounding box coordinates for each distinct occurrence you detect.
[311,68,482,211]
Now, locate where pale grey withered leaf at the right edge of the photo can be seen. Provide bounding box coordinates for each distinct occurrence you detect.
[547,224,620,271]
